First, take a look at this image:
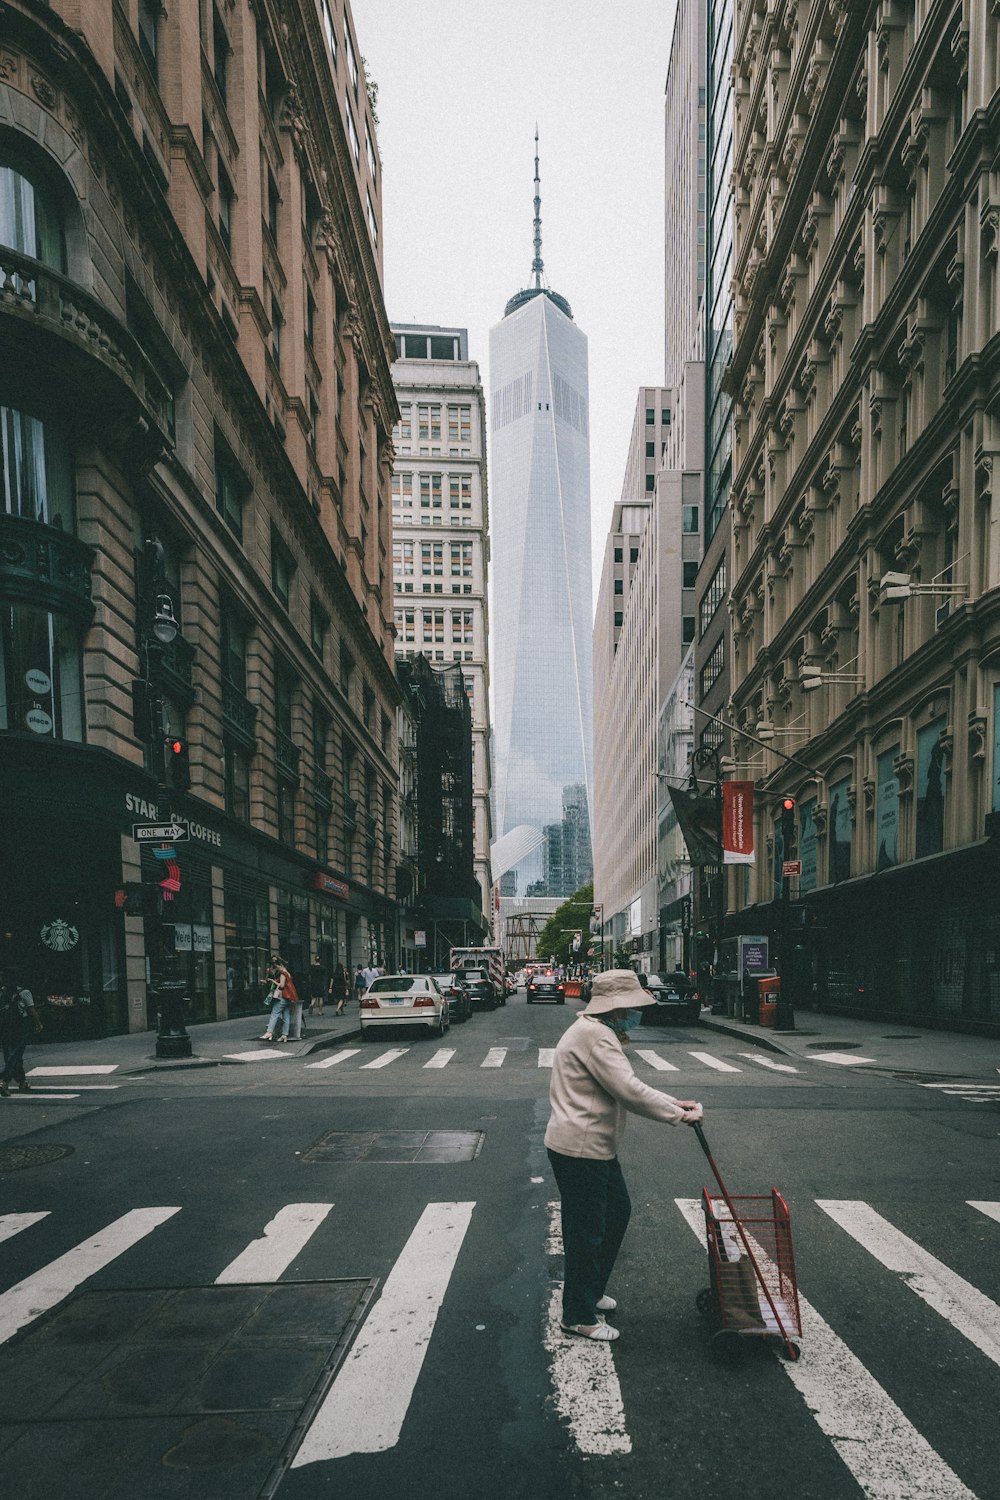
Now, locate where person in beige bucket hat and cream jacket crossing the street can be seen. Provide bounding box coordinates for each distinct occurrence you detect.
[546,969,702,1343]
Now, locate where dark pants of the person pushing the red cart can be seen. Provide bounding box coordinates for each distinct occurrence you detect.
[549,1151,631,1328]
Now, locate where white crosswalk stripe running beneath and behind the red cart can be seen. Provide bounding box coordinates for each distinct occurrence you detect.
[675,1199,976,1500]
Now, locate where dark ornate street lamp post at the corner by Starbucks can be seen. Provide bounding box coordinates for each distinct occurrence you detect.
[139,537,192,1058]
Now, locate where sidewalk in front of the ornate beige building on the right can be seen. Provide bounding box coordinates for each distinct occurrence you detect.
[702,1011,1000,1083]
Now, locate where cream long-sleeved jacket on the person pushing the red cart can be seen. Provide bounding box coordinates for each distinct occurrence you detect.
[546,1016,685,1161]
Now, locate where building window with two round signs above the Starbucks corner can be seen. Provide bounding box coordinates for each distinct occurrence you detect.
[0,603,84,741]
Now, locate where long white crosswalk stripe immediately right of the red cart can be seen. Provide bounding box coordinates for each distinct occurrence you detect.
[816,1199,1000,1365]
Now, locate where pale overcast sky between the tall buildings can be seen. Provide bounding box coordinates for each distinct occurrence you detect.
[351,0,675,600]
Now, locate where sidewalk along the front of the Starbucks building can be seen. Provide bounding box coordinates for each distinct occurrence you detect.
[24,1001,358,1074]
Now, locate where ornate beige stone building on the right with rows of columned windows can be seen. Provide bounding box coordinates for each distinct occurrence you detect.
[727,0,1000,1032]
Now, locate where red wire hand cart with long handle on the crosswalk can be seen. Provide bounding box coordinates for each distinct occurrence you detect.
[694,1125,802,1359]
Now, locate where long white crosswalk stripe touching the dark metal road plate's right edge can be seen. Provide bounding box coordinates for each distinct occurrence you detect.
[291,1203,475,1469]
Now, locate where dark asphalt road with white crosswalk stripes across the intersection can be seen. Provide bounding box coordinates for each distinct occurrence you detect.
[0,996,1000,1500]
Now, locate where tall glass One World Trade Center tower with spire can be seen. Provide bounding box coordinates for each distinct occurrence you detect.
[490,132,594,897]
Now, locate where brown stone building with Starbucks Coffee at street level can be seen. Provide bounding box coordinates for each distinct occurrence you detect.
[0,0,399,1035]
